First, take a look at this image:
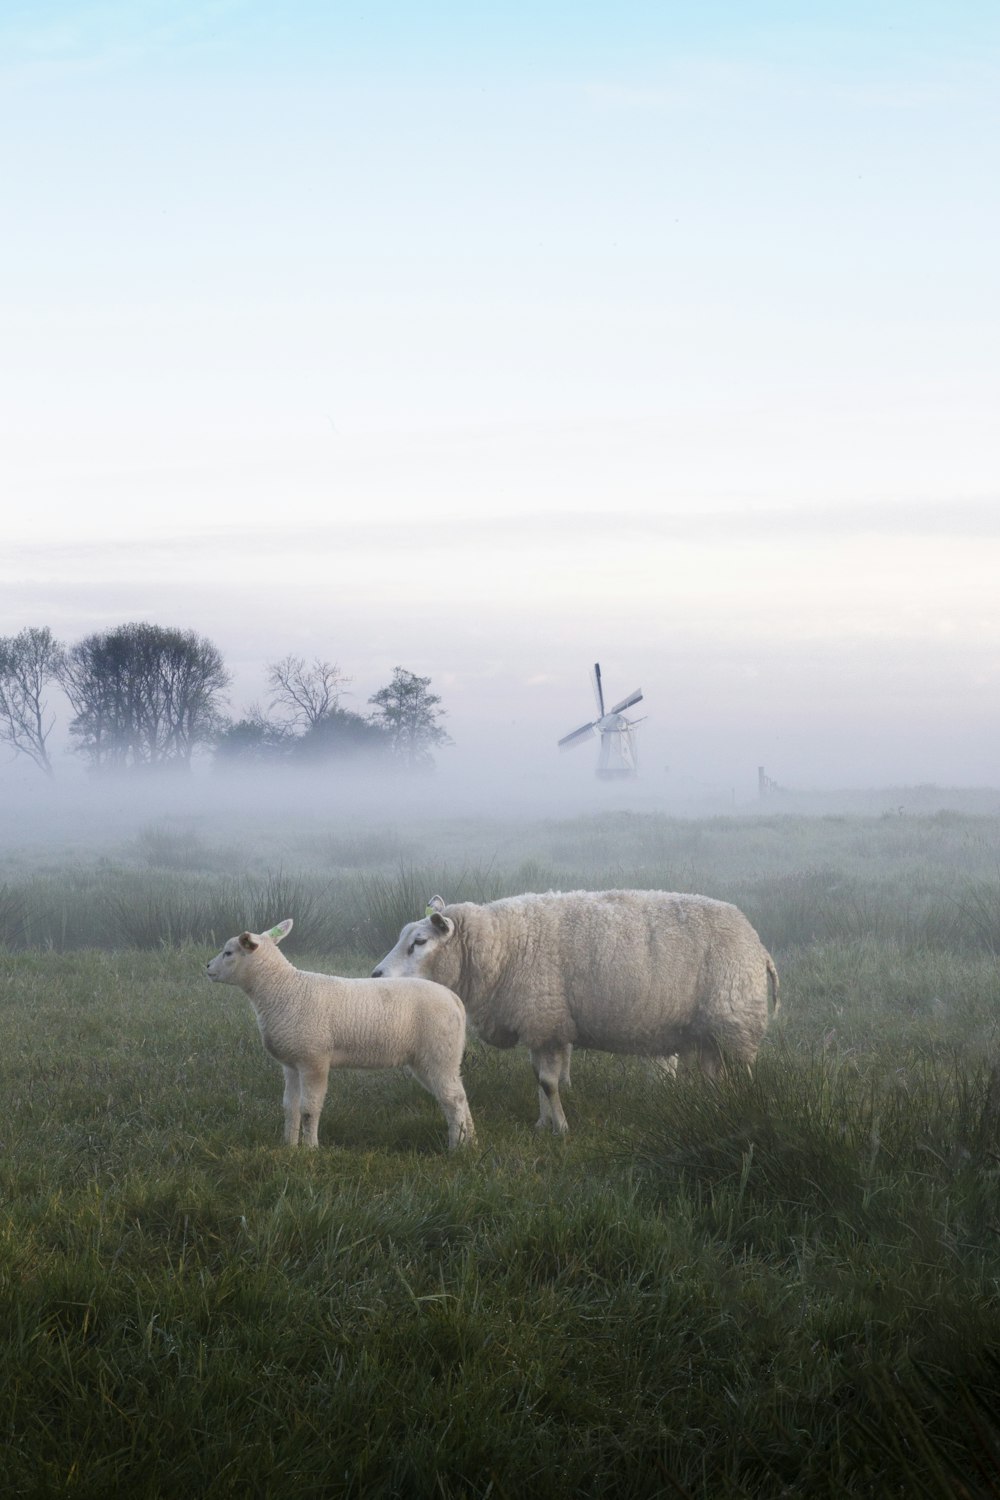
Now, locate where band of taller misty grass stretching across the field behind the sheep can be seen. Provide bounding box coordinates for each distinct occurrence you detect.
[0,860,1000,957]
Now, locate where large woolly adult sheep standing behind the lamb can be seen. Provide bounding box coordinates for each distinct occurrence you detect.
[372,891,780,1134]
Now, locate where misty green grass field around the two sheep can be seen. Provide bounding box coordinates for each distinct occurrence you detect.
[0,815,1000,1500]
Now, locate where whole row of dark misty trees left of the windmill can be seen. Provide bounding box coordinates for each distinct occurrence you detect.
[0,623,451,777]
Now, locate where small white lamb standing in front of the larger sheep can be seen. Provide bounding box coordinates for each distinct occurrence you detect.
[205,917,475,1149]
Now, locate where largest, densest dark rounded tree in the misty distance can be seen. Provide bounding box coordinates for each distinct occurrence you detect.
[61,624,229,770]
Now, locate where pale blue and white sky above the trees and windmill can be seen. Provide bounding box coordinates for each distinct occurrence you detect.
[0,0,1000,797]
